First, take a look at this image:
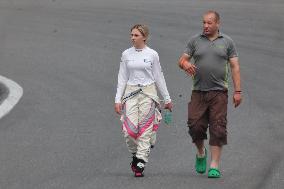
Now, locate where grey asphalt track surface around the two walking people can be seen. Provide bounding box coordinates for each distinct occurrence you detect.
[0,0,284,189]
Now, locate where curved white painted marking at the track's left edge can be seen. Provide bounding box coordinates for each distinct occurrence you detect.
[0,75,23,119]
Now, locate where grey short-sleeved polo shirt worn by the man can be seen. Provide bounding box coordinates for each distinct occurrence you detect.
[185,33,238,91]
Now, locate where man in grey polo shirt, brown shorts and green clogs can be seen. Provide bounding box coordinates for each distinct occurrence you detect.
[178,11,242,178]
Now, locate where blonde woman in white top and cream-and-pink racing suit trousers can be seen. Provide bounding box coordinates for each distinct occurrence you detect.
[115,24,172,177]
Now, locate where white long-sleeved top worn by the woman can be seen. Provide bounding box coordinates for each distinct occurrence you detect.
[115,46,171,103]
